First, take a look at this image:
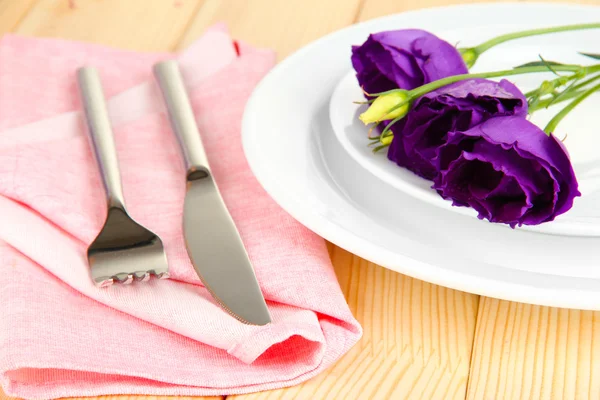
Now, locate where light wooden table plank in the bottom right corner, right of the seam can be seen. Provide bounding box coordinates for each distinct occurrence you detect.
[467,298,600,400]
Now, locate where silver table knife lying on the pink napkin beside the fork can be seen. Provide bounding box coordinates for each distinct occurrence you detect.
[154,60,271,325]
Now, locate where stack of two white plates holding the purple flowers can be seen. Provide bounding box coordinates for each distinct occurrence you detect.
[242,3,600,310]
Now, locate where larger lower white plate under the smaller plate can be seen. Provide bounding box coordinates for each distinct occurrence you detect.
[242,3,600,309]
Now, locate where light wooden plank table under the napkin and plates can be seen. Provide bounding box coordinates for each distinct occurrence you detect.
[0,0,600,400]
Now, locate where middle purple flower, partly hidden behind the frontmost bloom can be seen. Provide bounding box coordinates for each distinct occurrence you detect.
[388,79,527,179]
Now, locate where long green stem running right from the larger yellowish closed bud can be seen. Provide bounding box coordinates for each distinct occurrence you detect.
[408,64,600,99]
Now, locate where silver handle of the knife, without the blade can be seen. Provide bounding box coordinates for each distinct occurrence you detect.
[154,60,210,180]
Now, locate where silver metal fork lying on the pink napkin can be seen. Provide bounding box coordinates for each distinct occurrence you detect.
[77,67,169,287]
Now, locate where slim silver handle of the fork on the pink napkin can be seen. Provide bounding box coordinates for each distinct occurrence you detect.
[77,67,125,210]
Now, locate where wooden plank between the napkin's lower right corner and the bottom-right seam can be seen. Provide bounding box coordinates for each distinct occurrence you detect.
[228,247,478,400]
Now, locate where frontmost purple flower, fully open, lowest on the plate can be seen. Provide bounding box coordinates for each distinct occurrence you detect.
[433,116,581,228]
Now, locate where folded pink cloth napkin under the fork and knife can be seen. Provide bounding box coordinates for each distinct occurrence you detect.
[0,26,361,399]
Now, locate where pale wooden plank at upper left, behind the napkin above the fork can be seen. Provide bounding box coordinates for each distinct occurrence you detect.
[15,0,202,51]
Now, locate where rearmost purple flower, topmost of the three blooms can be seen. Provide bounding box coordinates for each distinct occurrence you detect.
[352,29,468,93]
